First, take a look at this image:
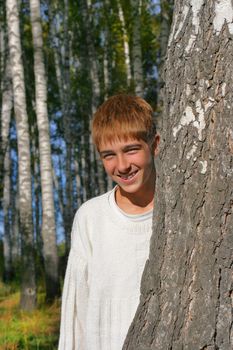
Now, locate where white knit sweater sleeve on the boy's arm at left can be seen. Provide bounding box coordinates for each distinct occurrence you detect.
[58,209,88,350]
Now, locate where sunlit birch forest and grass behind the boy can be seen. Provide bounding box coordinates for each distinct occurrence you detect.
[0,0,173,349]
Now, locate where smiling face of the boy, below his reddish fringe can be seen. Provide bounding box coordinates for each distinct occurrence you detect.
[99,136,159,195]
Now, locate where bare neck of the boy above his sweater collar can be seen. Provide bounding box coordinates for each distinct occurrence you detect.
[115,185,155,214]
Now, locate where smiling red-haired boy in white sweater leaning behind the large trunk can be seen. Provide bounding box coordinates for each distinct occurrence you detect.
[59,95,159,350]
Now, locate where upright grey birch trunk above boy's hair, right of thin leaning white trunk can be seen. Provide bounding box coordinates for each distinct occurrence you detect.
[130,0,144,96]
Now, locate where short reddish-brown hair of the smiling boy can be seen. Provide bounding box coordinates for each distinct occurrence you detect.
[92,94,156,150]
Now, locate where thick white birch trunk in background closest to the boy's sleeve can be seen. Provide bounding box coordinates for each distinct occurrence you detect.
[30,0,60,301]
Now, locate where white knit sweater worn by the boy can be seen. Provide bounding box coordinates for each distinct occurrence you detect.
[59,190,152,350]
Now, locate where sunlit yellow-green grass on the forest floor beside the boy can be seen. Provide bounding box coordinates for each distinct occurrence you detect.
[0,284,60,350]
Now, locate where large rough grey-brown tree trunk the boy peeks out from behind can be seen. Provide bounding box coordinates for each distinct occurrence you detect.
[123,0,233,350]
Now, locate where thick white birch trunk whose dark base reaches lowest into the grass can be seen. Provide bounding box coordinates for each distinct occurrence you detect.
[6,0,36,310]
